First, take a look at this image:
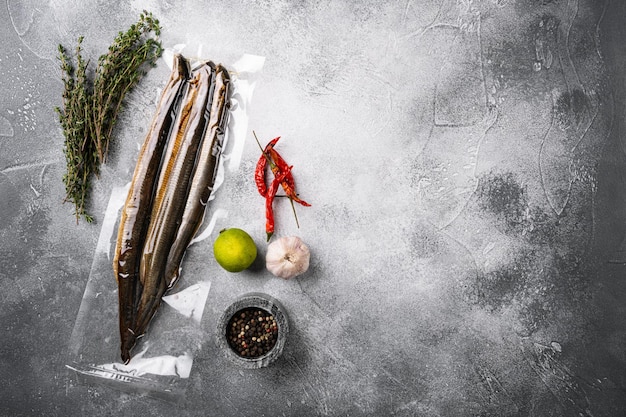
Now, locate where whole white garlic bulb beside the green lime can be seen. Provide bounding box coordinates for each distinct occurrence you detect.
[265,236,310,279]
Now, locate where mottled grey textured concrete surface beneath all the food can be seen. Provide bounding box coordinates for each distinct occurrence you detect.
[0,0,626,417]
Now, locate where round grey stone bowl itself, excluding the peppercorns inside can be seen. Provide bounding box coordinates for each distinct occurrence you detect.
[217,293,289,369]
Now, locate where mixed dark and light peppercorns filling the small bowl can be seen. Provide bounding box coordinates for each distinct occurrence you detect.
[226,307,278,359]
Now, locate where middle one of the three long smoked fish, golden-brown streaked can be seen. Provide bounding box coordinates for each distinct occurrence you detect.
[136,63,215,335]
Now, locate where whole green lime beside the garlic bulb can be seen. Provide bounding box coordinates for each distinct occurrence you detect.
[213,228,257,272]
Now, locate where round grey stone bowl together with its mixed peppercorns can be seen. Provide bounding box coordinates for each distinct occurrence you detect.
[217,293,289,369]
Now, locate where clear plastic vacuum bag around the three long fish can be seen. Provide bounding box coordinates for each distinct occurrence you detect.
[66,45,264,401]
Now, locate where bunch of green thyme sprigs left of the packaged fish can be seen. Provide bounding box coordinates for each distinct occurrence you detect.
[55,11,163,223]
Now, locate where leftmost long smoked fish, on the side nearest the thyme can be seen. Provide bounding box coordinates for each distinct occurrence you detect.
[113,55,189,363]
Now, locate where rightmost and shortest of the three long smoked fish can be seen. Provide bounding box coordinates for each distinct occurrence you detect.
[165,65,230,288]
